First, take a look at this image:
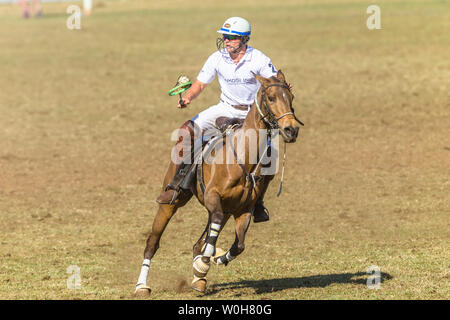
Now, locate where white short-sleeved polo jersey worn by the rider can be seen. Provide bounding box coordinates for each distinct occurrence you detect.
[197,46,277,106]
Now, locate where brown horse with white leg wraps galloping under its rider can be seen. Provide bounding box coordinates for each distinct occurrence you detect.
[135,70,303,296]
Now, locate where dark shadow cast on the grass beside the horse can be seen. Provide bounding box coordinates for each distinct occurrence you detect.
[207,272,393,295]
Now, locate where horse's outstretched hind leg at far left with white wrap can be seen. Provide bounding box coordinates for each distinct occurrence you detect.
[135,194,192,296]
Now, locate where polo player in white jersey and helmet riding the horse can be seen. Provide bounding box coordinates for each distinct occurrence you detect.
[157,17,277,222]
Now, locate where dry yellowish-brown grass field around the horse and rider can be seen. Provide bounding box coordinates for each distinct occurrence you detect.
[0,0,450,299]
